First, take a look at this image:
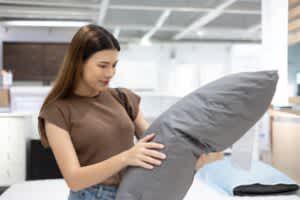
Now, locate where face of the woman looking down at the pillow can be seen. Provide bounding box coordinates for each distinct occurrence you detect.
[82,50,119,92]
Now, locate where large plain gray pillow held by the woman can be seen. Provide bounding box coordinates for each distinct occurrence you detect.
[116,71,278,200]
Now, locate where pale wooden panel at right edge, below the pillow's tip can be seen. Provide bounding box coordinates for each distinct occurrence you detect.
[272,121,300,183]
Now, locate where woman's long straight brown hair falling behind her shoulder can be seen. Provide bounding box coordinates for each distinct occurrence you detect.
[41,24,120,110]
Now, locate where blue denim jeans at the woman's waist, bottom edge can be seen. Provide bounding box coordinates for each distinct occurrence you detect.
[68,184,118,200]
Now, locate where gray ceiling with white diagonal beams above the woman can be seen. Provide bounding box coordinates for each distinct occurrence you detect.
[0,0,261,42]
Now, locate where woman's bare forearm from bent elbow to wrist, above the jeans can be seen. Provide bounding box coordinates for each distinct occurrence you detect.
[69,152,127,191]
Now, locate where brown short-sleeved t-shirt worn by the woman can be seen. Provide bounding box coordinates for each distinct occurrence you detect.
[38,88,140,185]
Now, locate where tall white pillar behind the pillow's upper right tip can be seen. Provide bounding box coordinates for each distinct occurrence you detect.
[262,0,288,105]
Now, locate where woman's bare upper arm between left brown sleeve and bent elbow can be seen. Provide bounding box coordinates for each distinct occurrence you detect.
[45,121,80,188]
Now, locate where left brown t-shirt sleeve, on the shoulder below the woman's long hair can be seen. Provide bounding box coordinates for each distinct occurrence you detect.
[38,103,70,148]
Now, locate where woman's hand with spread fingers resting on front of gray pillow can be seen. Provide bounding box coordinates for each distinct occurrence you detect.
[125,133,166,169]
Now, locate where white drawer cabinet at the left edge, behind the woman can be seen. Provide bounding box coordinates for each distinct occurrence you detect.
[0,113,29,186]
